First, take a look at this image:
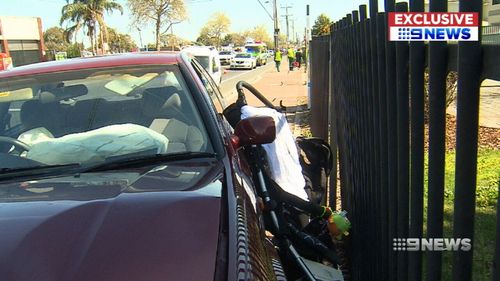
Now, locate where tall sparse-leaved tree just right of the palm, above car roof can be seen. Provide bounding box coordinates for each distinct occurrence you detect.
[127,0,187,50]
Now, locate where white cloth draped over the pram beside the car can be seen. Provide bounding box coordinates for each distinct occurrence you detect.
[241,105,309,201]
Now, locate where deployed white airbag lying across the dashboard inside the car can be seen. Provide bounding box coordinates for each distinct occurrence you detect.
[20,124,168,165]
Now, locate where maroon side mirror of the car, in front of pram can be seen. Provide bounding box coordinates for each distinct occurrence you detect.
[231,116,276,149]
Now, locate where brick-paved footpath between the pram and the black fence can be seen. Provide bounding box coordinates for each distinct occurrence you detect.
[247,59,308,136]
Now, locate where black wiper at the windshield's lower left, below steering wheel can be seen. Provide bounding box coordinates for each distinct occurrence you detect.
[0,163,81,180]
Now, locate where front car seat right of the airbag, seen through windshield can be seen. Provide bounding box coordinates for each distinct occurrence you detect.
[143,86,206,153]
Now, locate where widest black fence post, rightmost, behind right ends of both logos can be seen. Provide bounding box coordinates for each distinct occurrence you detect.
[453,0,482,281]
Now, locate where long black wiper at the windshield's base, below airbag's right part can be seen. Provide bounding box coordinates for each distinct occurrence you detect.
[79,152,216,173]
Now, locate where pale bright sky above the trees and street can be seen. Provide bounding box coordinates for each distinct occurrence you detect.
[0,0,383,45]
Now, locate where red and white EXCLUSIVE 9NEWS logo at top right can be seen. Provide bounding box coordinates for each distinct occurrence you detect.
[388,12,479,41]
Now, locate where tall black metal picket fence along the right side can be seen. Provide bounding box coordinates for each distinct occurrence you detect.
[311,0,500,280]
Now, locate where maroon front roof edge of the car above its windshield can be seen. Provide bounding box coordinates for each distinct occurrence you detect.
[0,52,181,79]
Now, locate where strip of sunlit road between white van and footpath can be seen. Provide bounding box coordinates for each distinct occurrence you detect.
[220,61,274,103]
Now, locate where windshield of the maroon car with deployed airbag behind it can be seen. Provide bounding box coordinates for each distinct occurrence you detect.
[0,65,213,170]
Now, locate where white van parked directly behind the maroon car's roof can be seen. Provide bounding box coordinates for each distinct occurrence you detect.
[182,46,222,85]
